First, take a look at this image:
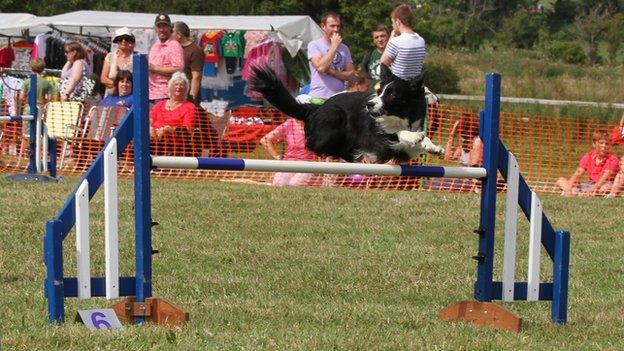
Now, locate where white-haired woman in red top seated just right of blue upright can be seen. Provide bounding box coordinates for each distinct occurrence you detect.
[150,72,195,139]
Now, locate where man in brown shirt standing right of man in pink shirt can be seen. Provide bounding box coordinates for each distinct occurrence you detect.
[173,22,204,105]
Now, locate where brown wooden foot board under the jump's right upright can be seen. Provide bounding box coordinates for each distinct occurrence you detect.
[439,301,522,333]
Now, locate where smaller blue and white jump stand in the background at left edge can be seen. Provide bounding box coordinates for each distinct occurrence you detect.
[0,74,61,183]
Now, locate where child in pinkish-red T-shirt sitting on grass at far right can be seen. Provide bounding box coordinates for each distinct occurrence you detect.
[557,130,618,196]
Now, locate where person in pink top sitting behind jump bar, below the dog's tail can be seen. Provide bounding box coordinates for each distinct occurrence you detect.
[260,118,317,186]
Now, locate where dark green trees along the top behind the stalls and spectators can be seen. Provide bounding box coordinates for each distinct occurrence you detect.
[0,0,624,64]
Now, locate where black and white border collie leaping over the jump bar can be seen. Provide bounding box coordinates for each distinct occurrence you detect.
[248,66,444,163]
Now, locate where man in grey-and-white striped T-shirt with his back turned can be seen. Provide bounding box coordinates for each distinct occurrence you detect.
[381,4,425,80]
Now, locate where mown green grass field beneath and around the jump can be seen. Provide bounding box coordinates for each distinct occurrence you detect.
[0,178,624,350]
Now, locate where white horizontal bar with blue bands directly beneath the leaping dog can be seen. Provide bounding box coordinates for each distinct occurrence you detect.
[152,156,487,179]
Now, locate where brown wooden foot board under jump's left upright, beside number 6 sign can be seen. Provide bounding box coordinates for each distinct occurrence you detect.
[111,297,189,327]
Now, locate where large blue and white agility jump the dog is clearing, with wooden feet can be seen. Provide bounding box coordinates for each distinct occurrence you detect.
[44,55,570,331]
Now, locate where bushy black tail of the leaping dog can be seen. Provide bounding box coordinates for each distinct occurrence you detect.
[247,66,318,122]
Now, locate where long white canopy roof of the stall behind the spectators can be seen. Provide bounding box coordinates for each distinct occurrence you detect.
[0,11,323,56]
